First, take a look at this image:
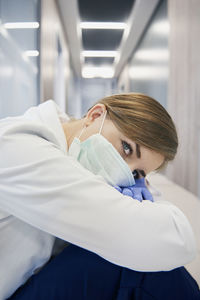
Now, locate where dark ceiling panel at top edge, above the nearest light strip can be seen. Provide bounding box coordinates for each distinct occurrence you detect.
[78,0,134,22]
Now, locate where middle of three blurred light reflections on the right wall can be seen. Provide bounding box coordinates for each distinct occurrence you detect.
[134,48,169,61]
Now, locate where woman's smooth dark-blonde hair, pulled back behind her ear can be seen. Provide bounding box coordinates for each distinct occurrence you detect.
[97,93,178,169]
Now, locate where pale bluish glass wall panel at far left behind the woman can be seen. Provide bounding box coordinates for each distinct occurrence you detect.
[0,0,39,118]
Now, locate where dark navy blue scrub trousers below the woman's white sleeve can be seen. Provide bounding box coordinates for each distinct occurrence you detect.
[9,245,200,300]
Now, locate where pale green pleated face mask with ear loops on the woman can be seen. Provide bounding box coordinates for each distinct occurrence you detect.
[68,111,135,187]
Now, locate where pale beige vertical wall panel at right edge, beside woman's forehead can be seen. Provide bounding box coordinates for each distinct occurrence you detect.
[167,0,200,196]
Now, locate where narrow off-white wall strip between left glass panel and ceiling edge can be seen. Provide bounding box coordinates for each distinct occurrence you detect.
[40,0,70,112]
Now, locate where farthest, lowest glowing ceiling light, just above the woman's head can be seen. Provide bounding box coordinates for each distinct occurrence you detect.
[82,66,114,78]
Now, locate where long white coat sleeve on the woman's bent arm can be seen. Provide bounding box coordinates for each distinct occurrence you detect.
[0,130,196,271]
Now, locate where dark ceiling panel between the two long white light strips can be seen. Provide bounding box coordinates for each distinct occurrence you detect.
[82,29,124,51]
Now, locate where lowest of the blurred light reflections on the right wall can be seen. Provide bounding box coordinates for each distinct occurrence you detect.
[129,66,169,80]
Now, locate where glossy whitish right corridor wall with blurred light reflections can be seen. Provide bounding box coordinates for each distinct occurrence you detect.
[118,0,169,107]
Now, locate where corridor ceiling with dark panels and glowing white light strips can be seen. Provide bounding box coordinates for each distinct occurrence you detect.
[57,0,160,78]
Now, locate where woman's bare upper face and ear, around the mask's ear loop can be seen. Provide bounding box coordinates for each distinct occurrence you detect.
[81,105,164,176]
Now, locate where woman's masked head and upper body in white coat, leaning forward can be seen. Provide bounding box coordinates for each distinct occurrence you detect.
[0,93,196,300]
